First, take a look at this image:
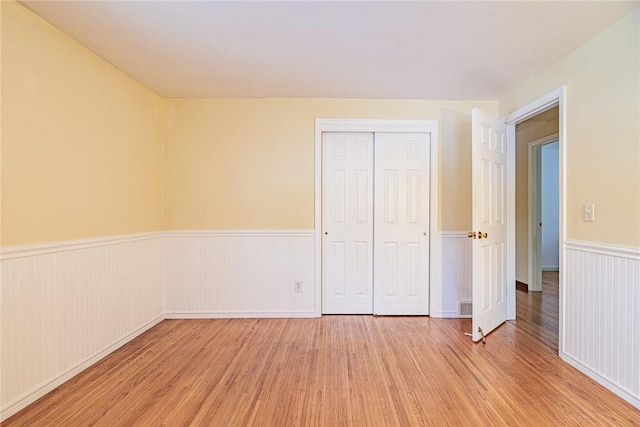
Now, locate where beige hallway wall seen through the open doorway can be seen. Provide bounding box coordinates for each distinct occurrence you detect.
[516,107,559,283]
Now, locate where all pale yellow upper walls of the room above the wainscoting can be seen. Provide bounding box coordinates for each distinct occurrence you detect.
[11,2,640,251]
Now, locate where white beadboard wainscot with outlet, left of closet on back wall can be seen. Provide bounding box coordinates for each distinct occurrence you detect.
[164,231,319,318]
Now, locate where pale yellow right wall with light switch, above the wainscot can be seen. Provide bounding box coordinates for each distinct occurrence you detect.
[500,10,640,247]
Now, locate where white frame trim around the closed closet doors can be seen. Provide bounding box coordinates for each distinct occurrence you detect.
[314,118,441,317]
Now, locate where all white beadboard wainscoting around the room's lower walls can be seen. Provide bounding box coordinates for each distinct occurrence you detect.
[0,231,640,420]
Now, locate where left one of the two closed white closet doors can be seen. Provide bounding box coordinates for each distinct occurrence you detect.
[322,132,374,314]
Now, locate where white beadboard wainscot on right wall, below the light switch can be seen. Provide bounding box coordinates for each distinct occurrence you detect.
[561,241,640,409]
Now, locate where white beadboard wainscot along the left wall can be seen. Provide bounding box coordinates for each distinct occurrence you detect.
[0,233,163,420]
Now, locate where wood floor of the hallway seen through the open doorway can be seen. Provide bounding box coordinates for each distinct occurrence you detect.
[513,271,560,353]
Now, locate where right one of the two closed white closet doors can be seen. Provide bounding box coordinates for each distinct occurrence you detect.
[373,133,430,315]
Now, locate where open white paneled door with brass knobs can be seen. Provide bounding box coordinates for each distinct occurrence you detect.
[470,108,508,341]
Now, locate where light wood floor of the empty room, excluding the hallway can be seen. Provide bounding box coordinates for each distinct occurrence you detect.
[3,316,640,427]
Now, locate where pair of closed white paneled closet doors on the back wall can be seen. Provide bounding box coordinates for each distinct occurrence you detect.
[322,132,432,315]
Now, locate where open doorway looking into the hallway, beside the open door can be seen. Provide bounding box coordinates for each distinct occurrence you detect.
[515,106,561,352]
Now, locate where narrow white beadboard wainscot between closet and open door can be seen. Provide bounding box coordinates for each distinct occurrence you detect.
[431,231,472,318]
